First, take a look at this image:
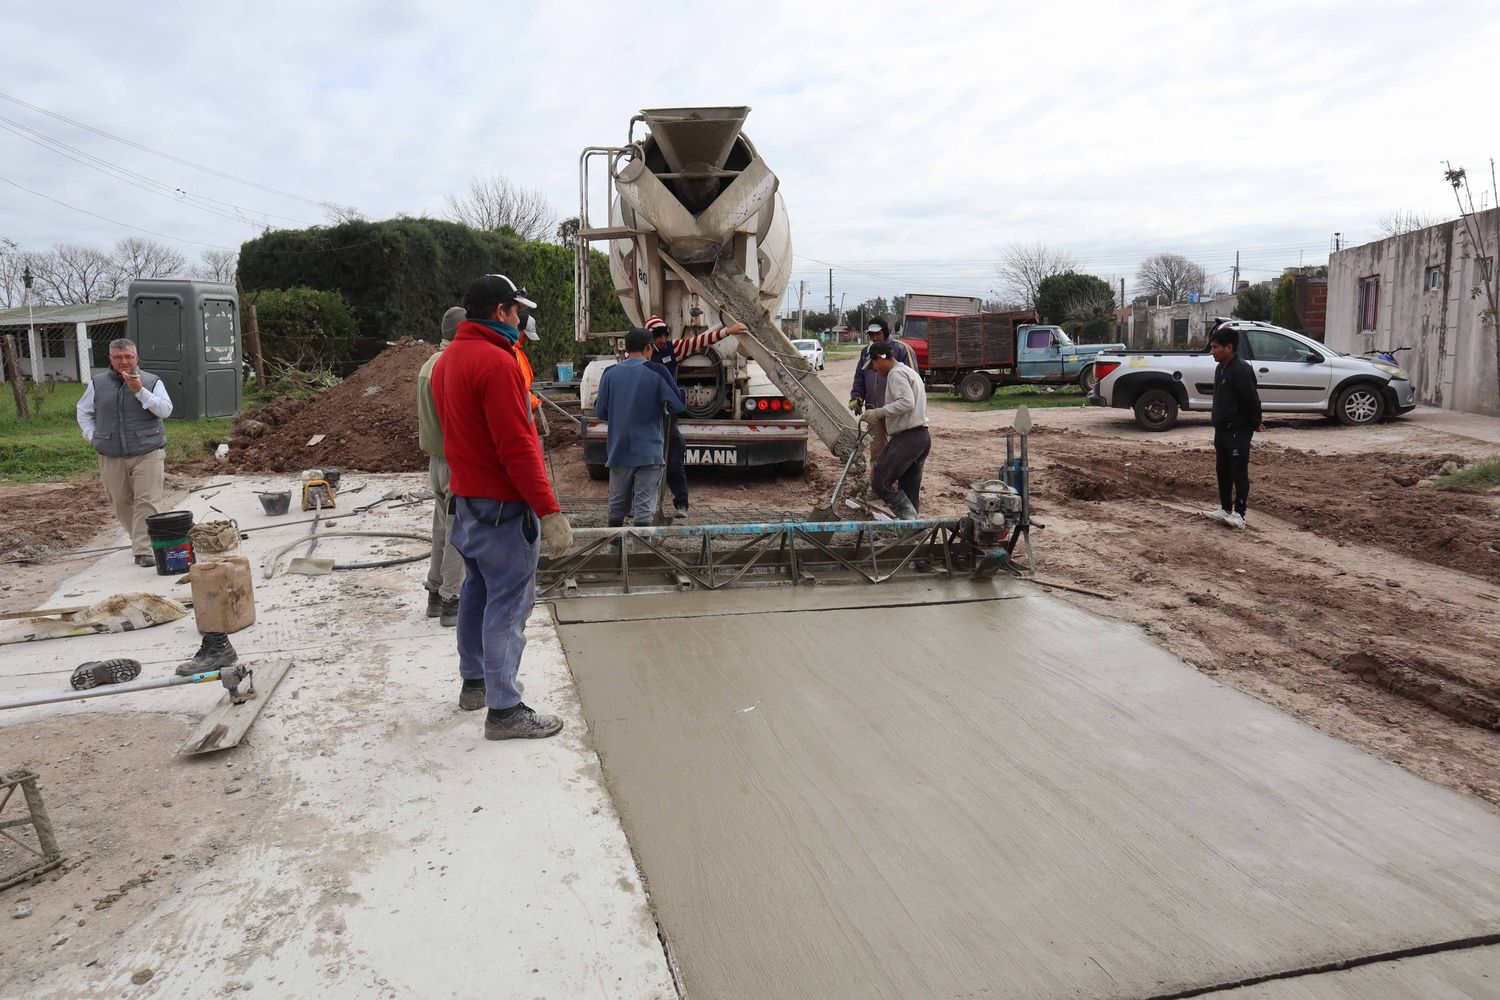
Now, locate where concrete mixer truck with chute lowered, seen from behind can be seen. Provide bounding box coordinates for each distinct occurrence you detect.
[573,108,861,478]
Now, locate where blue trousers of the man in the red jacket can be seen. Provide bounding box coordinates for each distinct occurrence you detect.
[453,496,542,708]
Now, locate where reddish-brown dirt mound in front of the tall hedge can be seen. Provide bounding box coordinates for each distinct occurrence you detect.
[227,339,437,472]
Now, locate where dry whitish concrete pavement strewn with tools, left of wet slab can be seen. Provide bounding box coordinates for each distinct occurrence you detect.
[0,474,677,1000]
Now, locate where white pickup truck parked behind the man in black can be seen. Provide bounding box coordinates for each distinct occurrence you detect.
[1088,319,1416,430]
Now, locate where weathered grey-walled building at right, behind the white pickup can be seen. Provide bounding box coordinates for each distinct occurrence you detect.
[1326,208,1500,417]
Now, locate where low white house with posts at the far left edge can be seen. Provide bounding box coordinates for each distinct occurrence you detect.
[0,298,126,382]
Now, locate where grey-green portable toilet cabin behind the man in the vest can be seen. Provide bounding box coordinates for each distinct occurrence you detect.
[125,277,245,420]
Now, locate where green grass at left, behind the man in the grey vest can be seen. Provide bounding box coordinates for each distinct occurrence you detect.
[0,382,234,483]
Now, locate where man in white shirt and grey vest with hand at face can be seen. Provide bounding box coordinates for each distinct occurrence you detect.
[77,337,173,567]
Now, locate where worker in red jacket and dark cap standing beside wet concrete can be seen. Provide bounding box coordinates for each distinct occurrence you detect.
[432,274,573,739]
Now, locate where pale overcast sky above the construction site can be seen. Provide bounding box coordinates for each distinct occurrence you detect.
[0,0,1500,307]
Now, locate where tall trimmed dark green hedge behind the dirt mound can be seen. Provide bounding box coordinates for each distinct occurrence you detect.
[240,219,629,379]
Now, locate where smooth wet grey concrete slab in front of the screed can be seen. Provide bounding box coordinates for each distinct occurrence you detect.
[561,588,1500,999]
